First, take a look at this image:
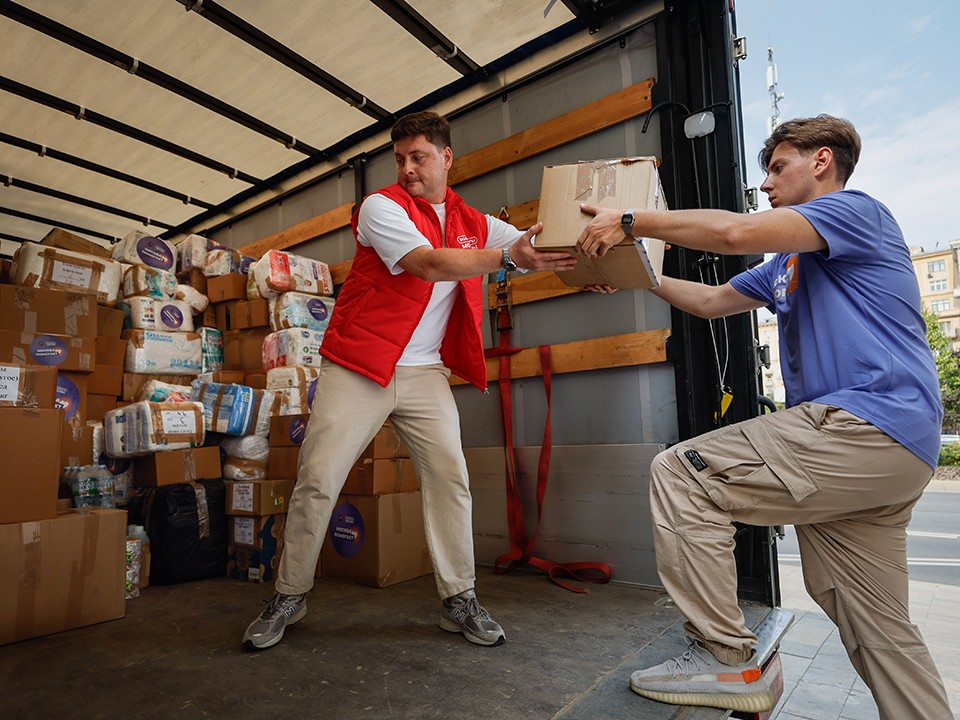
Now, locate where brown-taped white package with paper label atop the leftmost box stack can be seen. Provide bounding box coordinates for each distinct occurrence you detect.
[10,243,123,307]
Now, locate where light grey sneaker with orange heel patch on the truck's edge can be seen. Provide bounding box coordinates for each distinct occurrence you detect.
[630,640,777,713]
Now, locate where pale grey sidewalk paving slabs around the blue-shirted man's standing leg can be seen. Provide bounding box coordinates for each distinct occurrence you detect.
[771,540,960,720]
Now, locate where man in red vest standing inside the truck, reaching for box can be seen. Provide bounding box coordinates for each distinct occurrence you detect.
[243,112,576,650]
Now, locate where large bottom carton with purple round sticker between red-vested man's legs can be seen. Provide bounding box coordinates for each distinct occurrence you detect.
[320,491,433,587]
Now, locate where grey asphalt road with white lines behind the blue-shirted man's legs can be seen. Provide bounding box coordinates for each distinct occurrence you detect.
[778,490,960,586]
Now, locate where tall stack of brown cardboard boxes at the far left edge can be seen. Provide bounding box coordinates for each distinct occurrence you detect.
[0,231,126,644]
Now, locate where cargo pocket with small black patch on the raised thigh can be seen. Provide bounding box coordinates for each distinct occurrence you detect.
[674,421,820,511]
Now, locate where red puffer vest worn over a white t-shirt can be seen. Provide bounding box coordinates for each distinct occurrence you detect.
[320,184,487,390]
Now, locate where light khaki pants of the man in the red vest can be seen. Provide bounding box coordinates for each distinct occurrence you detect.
[276,360,475,598]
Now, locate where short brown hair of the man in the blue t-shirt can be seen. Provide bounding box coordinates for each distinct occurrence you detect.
[757,115,860,186]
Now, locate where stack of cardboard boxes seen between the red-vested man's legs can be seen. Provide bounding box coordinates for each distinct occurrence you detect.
[321,422,433,587]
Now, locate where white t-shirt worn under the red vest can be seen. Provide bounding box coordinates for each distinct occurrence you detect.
[357,195,523,366]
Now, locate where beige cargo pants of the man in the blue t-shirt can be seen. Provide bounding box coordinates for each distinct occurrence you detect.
[650,403,953,720]
